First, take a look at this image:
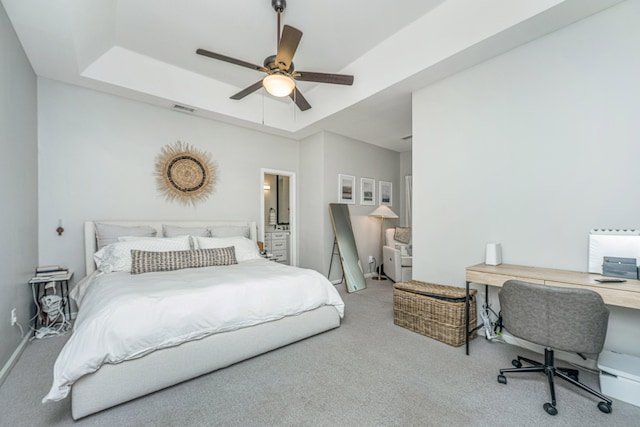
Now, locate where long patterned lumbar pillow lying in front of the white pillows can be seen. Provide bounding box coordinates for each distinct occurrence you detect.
[131,246,237,274]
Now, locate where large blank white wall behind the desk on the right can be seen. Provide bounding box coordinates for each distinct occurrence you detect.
[413,1,640,355]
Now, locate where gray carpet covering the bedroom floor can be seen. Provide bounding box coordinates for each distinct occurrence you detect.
[0,280,640,426]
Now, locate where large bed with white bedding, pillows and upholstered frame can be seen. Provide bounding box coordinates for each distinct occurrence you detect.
[43,221,344,419]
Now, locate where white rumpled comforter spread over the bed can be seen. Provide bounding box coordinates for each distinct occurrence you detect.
[43,260,344,402]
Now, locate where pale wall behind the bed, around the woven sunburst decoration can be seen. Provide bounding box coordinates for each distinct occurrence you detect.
[38,78,299,280]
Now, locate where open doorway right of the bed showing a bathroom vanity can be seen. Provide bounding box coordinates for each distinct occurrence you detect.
[259,169,298,265]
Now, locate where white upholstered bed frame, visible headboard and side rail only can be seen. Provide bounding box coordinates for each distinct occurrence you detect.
[71,221,340,420]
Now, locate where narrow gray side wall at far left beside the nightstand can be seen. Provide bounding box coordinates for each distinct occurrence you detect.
[0,4,38,381]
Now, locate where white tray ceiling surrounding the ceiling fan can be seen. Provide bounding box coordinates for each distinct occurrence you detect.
[2,0,621,152]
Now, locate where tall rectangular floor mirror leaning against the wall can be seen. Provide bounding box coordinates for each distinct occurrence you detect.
[329,203,367,292]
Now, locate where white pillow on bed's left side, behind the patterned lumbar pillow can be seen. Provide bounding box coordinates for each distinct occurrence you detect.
[93,236,191,273]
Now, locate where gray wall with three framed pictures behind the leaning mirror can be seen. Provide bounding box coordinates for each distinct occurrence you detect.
[300,132,400,280]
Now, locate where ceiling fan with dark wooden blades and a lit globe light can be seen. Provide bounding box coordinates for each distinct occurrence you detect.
[196,0,353,111]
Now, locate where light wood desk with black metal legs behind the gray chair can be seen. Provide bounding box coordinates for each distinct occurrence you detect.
[465,264,640,354]
